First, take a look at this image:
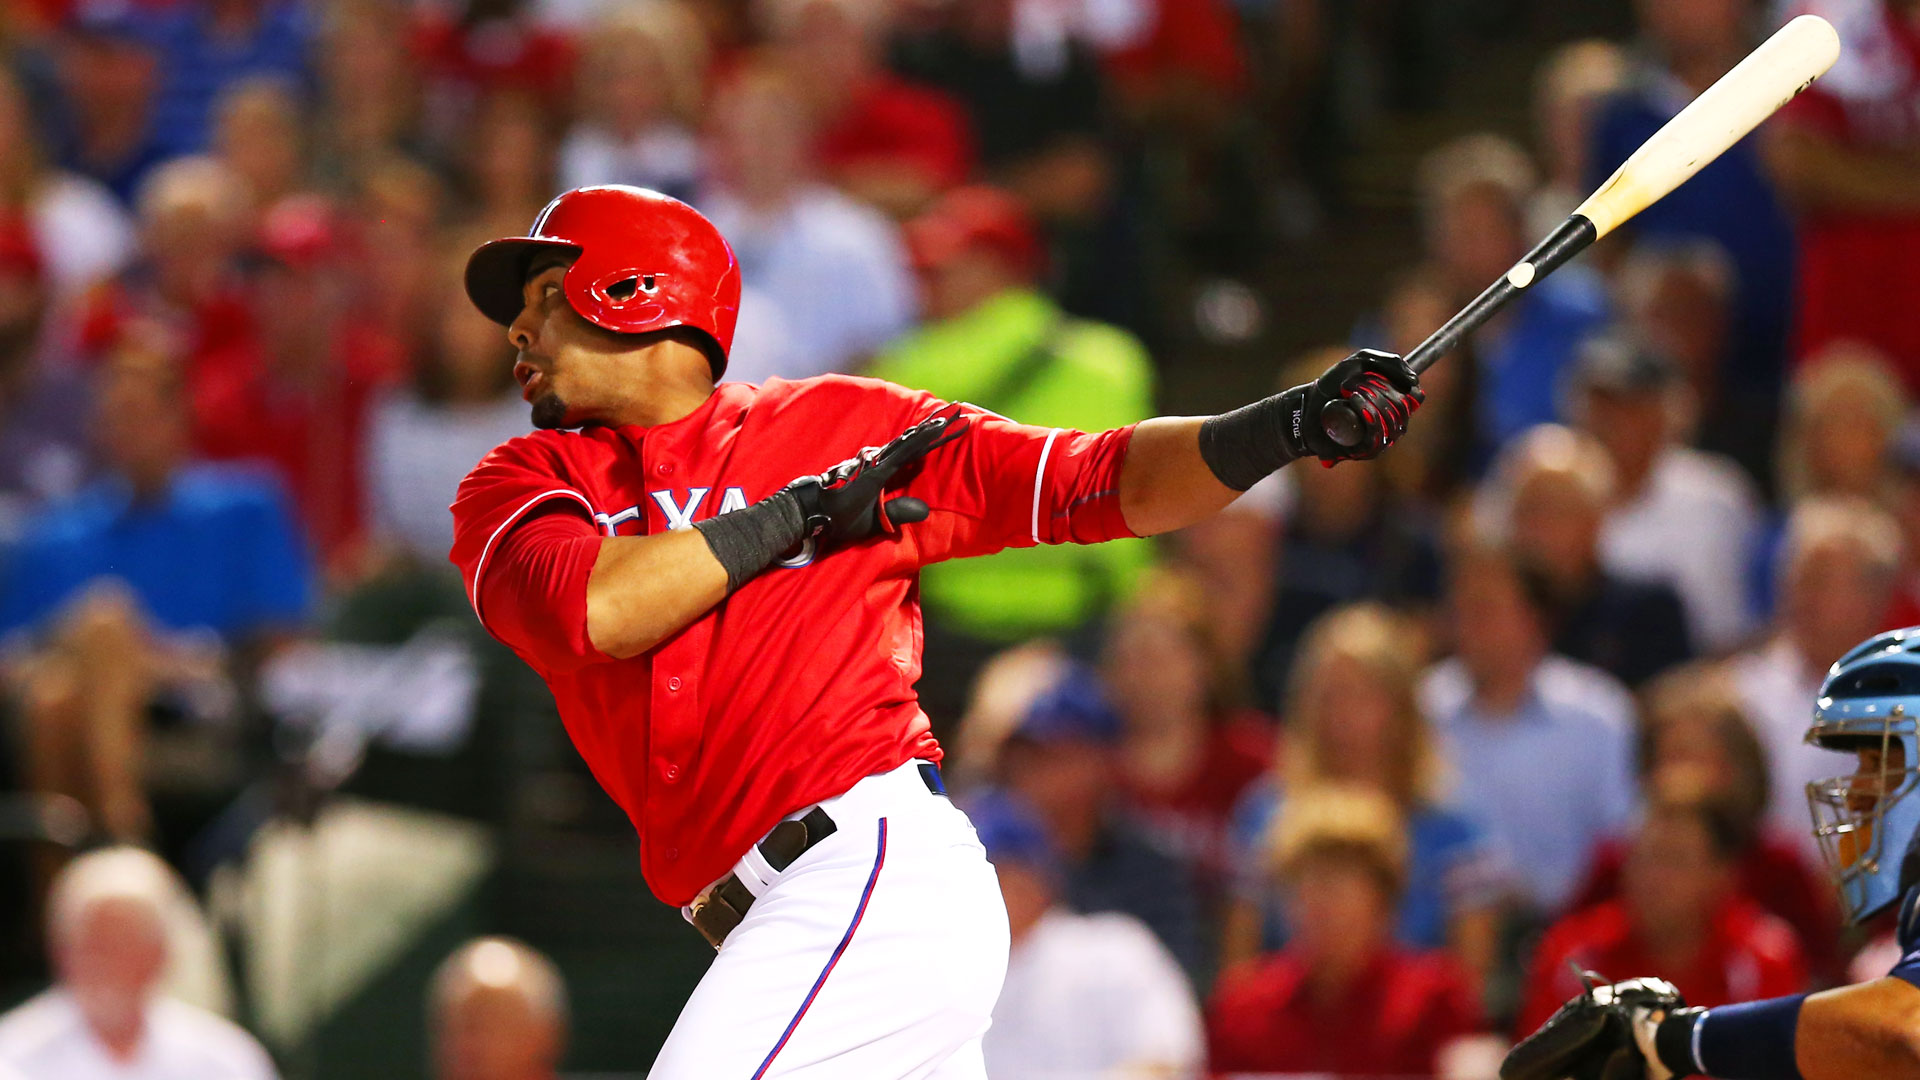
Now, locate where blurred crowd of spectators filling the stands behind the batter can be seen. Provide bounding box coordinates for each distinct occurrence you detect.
[0,0,1920,1080]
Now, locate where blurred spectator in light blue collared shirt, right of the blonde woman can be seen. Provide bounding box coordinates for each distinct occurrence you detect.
[1419,548,1634,913]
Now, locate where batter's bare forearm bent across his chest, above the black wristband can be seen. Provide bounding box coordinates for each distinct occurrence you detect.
[588,528,728,659]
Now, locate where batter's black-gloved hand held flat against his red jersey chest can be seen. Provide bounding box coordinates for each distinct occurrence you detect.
[785,405,970,544]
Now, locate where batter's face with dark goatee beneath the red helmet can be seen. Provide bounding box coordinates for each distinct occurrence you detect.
[507,256,626,429]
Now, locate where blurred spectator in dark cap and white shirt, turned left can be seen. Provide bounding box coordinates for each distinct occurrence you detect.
[1571,334,1761,655]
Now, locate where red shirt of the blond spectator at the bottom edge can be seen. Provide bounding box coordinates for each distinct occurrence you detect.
[1206,949,1480,1076]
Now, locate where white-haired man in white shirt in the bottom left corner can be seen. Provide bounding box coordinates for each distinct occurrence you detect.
[0,847,276,1080]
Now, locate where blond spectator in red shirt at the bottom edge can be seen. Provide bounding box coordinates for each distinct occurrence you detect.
[1208,788,1478,1076]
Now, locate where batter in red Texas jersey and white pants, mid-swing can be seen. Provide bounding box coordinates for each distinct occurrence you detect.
[441,186,1421,1080]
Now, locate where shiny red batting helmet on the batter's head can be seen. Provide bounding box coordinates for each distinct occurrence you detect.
[467,184,739,379]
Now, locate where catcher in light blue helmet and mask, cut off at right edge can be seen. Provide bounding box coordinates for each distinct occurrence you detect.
[1500,626,1920,1080]
